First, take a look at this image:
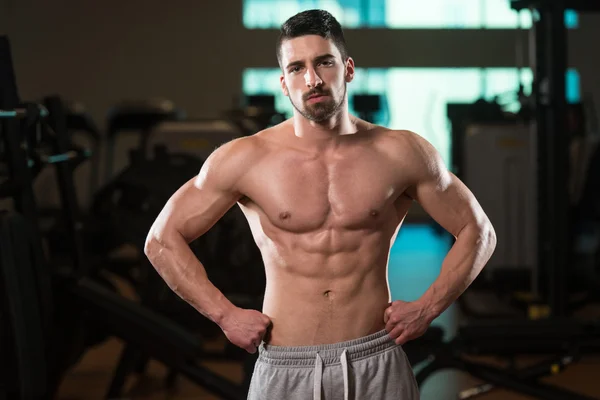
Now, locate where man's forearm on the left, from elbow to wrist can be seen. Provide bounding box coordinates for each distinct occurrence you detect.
[145,234,234,325]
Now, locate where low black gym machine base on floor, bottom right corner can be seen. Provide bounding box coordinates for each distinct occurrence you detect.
[416,318,600,400]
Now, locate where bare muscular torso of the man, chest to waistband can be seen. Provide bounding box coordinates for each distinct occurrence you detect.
[239,117,412,346]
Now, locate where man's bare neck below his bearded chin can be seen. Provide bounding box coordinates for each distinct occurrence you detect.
[294,107,357,139]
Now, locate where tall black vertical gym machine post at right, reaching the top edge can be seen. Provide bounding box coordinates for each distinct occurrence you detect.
[511,1,580,316]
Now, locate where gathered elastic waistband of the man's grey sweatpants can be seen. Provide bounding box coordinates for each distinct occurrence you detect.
[258,329,398,367]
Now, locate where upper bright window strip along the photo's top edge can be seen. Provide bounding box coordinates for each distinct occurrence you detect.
[243,0,579,29]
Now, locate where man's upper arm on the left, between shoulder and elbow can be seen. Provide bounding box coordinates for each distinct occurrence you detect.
[153,179,237,243]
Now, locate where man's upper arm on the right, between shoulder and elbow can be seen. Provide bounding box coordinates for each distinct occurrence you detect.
[413,172,484,236]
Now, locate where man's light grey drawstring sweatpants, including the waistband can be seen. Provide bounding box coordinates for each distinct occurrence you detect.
[248,330,419,400]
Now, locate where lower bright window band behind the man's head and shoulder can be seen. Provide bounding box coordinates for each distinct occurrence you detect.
[243,68,580,165]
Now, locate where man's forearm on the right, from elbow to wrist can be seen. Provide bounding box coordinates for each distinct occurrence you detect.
[419,223,496,320]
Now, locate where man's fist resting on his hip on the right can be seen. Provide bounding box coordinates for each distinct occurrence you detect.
[383,300,431,345]
